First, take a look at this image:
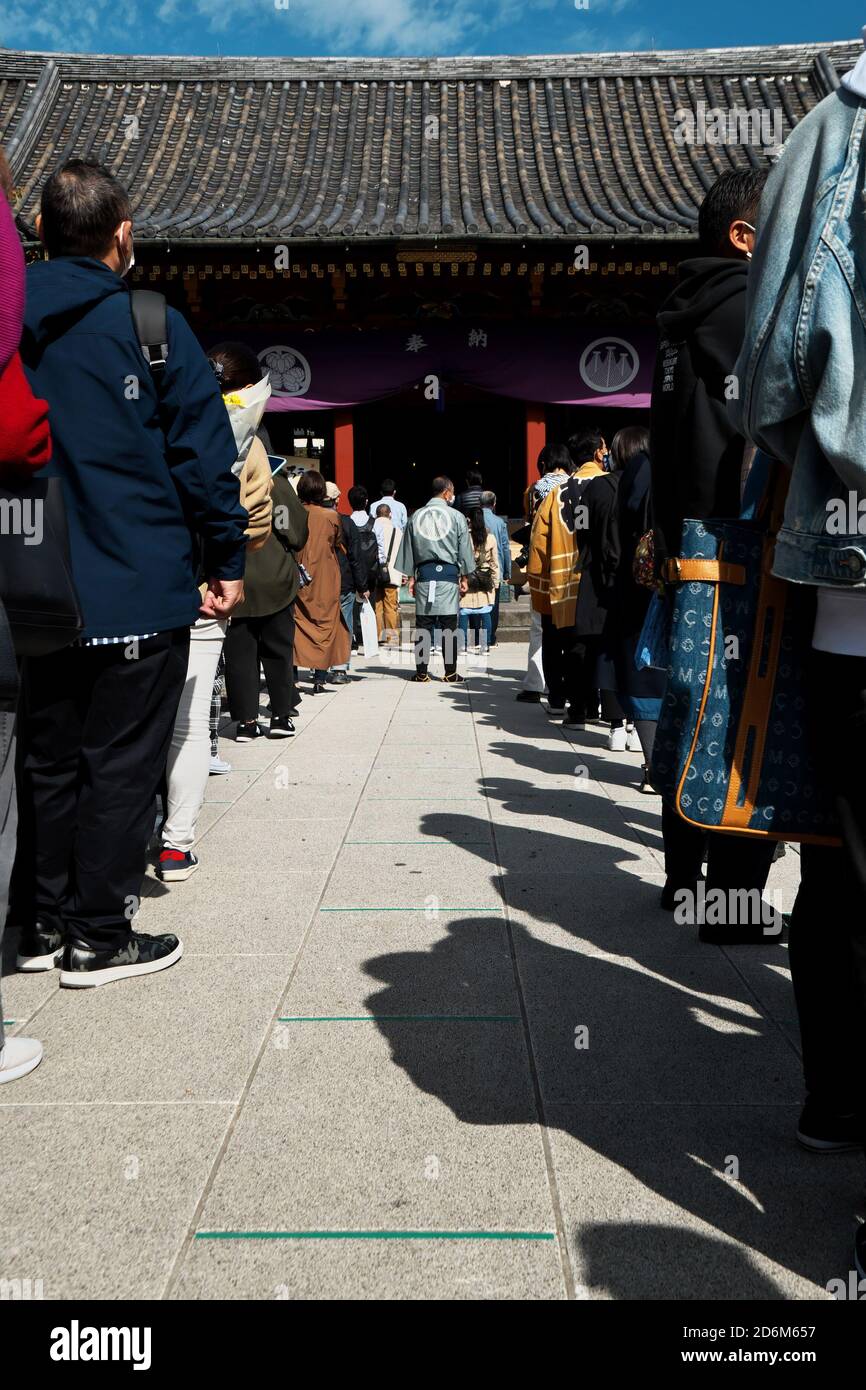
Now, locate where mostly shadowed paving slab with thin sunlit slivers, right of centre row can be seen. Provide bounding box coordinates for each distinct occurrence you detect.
[516,931,802,1105]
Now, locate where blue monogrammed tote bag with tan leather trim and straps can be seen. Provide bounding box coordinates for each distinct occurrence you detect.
[652,455,840,845]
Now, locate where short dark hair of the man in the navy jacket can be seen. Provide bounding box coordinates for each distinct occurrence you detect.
[39,160,132,260]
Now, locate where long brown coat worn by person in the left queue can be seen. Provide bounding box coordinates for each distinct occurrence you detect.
[295,503,352,671]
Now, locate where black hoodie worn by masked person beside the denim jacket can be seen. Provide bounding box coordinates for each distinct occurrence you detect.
[649,256,748,559]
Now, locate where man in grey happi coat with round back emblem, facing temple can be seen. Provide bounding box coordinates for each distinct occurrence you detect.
[395,478,475,685]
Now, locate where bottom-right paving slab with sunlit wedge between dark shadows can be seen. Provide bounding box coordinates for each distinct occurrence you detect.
[546,1097,862,1295]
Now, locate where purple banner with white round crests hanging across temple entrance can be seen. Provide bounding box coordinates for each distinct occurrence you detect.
[207,320,656,410]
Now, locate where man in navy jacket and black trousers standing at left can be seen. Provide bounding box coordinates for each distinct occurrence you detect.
[17,160,247,987]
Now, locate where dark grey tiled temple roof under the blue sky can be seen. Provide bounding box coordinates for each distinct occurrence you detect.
[0,40,862,245]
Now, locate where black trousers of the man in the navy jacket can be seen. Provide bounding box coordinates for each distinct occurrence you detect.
[15,627,189,949]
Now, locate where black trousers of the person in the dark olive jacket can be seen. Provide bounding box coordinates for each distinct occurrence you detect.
[224,603,295,724]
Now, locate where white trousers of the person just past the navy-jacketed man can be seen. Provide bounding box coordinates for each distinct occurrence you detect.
[163,617,228,853]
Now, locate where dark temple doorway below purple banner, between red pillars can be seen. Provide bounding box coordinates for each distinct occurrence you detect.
[353,386,525,517]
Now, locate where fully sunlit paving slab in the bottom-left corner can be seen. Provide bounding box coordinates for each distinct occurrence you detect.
[0,1100,232,1304]
